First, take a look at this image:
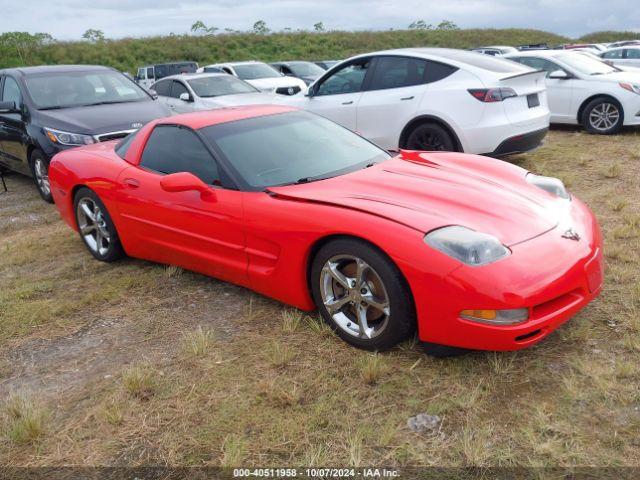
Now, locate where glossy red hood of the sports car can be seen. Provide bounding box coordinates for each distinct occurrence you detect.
[269,152,566,245]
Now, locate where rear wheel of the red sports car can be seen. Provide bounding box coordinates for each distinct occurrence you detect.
[73,188,124,262]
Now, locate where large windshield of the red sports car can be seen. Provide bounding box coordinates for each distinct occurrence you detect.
[201,111,390,190]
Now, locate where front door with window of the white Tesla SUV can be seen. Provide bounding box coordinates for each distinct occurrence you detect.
[305,57,372,131]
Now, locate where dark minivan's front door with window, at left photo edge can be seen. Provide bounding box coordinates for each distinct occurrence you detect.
[0,76,30,174]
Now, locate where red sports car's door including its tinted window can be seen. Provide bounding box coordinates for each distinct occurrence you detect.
[112,125,247,284]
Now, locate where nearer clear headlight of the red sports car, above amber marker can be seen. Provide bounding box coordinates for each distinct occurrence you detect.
[424,226,511,266]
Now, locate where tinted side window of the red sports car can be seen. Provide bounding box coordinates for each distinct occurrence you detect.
[140,125,220,185]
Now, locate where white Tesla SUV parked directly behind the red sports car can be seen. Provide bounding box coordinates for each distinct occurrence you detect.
[280,48,549,156]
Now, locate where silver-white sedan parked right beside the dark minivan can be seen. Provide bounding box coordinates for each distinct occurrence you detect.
[151,73,274,114]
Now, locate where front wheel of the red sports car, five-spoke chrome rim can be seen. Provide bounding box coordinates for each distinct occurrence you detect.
[311,239,416,350]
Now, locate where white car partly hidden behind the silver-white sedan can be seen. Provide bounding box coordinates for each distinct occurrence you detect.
[198,61,307,95]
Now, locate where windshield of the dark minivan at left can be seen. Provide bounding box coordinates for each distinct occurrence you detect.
[25,70,151,110]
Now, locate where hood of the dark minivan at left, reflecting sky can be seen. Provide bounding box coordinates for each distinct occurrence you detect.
[37,100,171,135]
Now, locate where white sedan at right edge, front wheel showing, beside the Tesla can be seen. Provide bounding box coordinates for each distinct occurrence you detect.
[506,50,640,135]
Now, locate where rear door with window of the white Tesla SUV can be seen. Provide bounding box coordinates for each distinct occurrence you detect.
[356,55,428,150]
